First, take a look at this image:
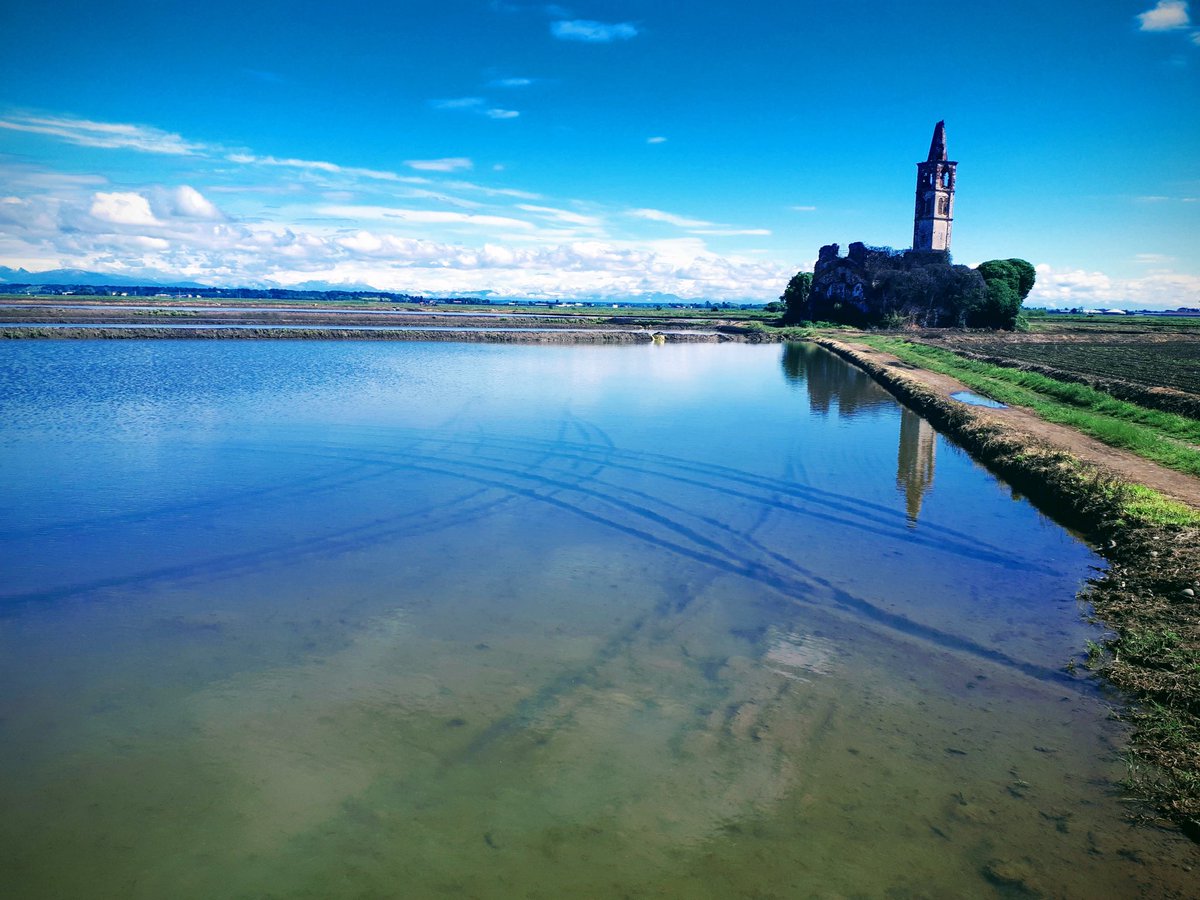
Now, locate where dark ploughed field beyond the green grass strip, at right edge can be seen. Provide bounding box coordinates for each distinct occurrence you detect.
[964,340,1200,394]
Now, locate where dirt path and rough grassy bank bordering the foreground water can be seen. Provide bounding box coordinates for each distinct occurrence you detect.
[816,337,1200,840]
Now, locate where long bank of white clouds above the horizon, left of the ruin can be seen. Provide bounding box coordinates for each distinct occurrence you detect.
[7,181,791,300]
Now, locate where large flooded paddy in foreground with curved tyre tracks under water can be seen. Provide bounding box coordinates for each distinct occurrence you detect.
[0,341,1198,898]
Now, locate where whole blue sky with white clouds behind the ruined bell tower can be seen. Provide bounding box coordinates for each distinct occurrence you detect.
[0,0,1200,307]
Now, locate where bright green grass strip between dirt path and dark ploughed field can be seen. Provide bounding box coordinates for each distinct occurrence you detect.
[859,336,1200,476]
